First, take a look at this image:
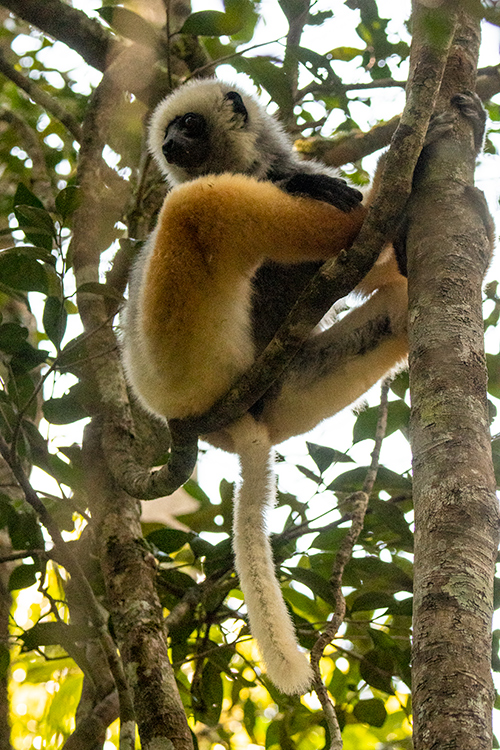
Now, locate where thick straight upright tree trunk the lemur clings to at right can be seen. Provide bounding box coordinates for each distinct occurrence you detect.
[407,3,499,750]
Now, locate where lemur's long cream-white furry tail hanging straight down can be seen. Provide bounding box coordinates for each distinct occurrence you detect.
[231,416,312,694]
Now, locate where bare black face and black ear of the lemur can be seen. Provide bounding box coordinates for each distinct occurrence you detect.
[162,91,248,169]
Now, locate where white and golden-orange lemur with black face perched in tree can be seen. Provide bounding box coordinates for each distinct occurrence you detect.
[123,79,490,693]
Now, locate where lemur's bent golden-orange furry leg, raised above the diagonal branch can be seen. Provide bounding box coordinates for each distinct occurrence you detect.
[137,174,365,424]
